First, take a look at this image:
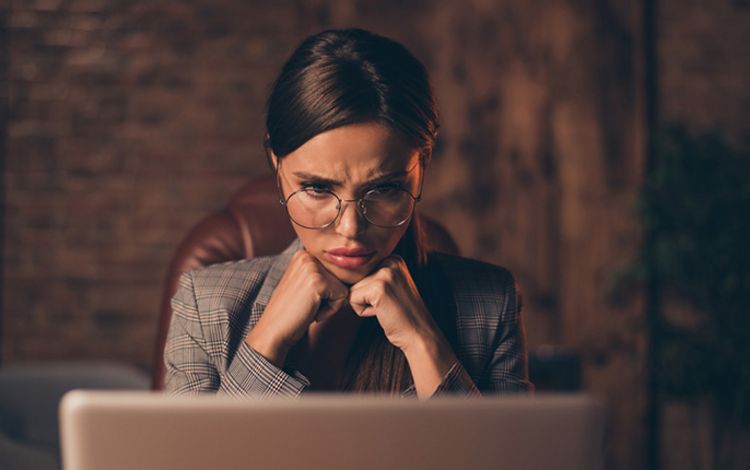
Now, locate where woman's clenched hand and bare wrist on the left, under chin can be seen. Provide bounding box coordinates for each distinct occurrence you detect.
[246,249,349,367]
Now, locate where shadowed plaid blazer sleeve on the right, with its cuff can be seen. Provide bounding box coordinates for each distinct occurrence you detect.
[433,274,534,396]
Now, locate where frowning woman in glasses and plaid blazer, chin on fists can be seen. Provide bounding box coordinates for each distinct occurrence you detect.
[165,30,531,398]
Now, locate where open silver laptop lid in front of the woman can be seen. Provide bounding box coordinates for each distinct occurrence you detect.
[60,390,604,470]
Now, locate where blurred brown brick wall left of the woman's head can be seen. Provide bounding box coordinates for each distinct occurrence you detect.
[3,1,296,368]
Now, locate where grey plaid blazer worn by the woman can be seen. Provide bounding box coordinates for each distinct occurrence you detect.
[164,239,533,397]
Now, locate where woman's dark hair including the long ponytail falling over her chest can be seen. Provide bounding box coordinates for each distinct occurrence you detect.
[265,29,439,392]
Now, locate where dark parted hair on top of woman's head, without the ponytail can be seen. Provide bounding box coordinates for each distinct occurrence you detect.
[266,29,439,163]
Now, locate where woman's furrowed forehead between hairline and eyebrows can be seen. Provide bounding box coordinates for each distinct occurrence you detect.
[282,123,419,181]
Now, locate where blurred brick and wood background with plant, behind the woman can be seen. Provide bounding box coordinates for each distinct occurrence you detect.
[0,0,750,469]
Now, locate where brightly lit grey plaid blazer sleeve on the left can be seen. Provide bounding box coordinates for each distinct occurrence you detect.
[164,271,310,397]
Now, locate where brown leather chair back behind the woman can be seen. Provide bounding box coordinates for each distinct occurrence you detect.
[152,175,458,390]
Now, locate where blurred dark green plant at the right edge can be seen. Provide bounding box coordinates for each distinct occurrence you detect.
[641,125,750,468]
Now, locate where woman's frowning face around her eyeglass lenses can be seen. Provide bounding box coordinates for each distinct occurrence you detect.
[274,123,424,284]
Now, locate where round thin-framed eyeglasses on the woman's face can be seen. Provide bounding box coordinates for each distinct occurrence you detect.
[276,165,423,230]
